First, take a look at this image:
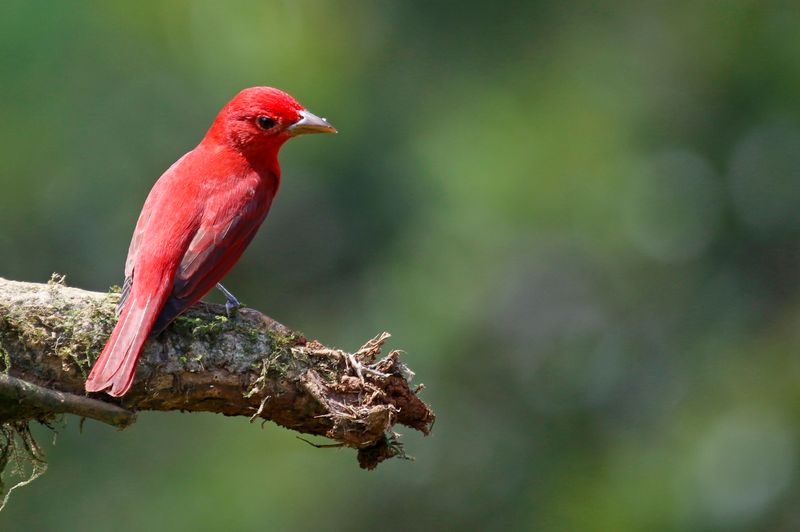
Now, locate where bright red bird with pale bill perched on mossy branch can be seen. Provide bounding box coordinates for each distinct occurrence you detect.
[86,87,336,397]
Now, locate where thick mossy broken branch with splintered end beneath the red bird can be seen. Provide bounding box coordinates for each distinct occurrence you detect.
[0,277,434,469]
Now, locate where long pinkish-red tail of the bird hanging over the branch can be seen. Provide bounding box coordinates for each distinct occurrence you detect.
[86,290,163,397]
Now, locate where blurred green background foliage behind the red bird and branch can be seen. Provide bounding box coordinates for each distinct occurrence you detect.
[0,0,800,531]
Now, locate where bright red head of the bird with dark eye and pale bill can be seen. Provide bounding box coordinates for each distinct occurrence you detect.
[207,87,336,156]
